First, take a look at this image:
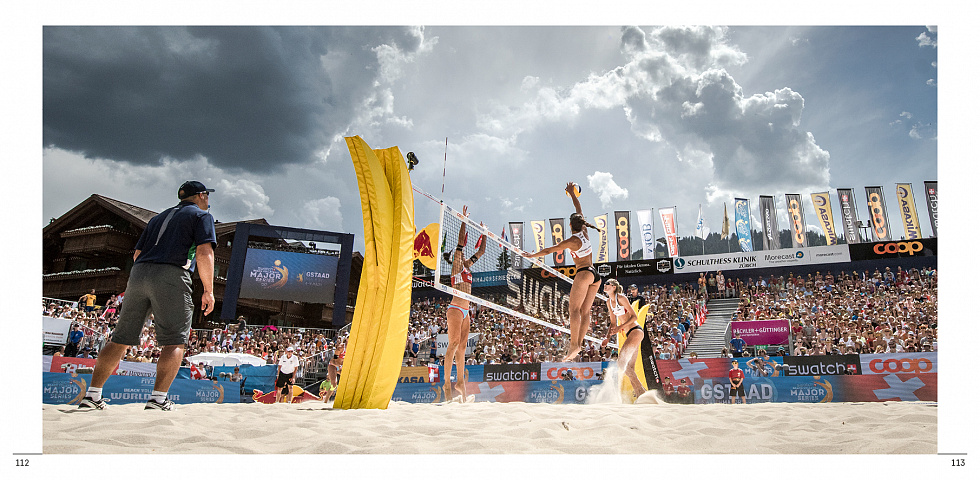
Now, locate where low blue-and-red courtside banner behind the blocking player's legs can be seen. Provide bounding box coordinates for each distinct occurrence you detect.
[391,380,600,404]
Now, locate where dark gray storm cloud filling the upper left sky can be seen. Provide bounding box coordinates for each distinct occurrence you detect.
[43,27,421,171]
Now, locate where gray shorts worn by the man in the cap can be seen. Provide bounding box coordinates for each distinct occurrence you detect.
[112,263,194,346]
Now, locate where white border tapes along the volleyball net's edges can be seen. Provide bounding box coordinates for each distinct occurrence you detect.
[412,185,618,349]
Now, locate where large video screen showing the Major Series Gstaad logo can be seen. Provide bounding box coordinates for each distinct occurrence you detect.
[240,248,340,304]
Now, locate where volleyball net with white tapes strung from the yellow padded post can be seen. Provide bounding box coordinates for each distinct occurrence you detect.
[412,186,617,348]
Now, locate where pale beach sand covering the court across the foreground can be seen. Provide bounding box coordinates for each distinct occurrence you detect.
[42,402,938,455]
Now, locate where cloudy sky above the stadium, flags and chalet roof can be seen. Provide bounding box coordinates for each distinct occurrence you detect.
[42,25,939,250]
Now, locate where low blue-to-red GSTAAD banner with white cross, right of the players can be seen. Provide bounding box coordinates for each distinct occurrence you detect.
[691,374,938,404]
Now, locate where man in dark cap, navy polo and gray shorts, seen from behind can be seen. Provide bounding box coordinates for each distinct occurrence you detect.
[78,181,217,411]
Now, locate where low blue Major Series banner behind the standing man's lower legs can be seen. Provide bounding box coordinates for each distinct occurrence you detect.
[41,372,241,405]
